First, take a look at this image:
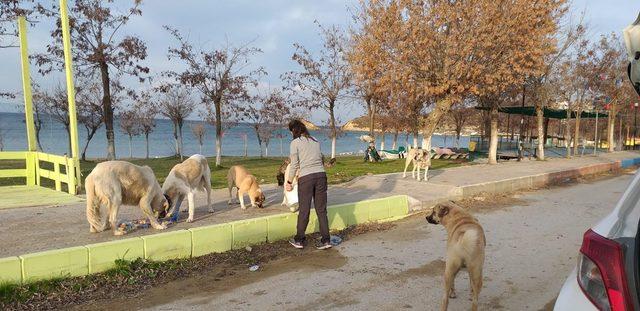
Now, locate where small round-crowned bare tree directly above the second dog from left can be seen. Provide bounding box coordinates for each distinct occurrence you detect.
[158,84,196,160]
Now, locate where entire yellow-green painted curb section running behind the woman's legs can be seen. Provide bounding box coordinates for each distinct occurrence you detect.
[0,195,409,283]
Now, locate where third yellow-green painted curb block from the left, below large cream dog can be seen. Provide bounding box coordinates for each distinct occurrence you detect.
[86,238,144,273]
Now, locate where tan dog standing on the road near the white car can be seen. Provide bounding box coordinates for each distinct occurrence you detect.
[426,202,487,311]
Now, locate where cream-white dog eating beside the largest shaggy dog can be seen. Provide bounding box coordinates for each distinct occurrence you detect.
[162,154,213,222]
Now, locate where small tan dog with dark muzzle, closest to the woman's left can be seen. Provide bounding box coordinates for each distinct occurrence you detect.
[227,165,265,209]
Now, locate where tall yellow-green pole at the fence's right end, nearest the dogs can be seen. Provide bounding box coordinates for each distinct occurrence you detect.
[60,0,82,194]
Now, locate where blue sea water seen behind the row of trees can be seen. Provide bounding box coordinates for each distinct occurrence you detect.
[0,112,469,159]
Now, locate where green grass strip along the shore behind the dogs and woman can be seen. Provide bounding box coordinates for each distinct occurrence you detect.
[0,156,463,189]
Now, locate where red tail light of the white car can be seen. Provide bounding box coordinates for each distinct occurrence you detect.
[578,230,633,311]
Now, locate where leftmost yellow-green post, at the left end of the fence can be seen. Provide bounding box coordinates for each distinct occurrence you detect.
[18,16,38,186]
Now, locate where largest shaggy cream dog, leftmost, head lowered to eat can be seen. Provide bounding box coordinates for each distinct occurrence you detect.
[85,161,170,235]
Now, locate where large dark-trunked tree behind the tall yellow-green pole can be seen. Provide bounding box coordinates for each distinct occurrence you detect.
[34,0,149,159]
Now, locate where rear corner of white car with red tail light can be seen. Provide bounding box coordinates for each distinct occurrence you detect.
[554,171,640,311]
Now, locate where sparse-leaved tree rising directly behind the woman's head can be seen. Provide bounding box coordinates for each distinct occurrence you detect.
[282,24,352,159]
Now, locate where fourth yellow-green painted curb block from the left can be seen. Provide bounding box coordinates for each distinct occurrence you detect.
[142,230,191,261]
